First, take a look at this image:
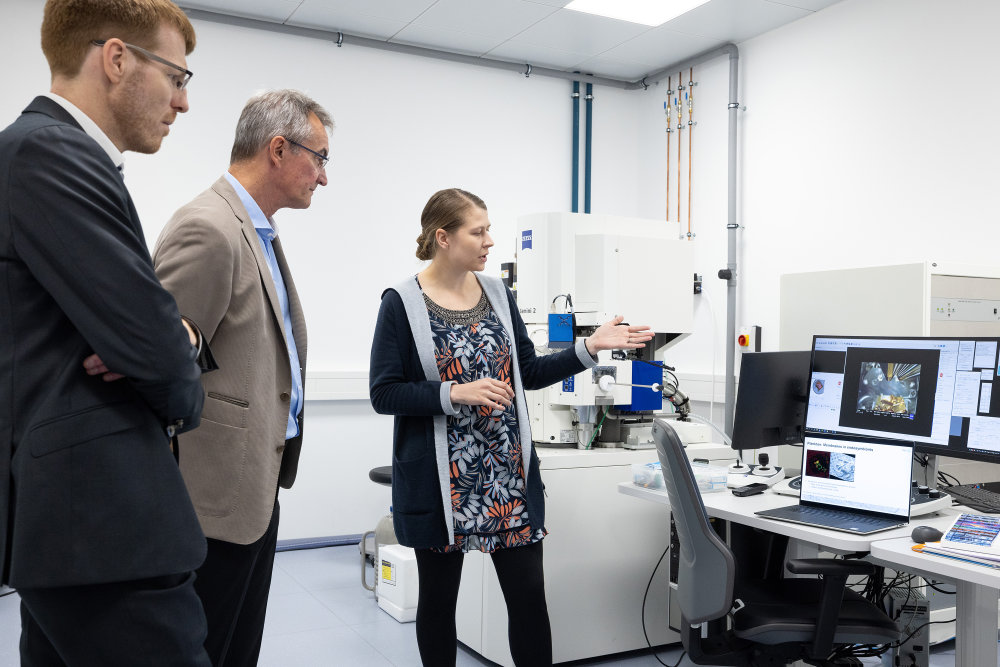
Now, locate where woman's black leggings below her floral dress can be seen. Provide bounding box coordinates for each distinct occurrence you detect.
[415,541,552,667]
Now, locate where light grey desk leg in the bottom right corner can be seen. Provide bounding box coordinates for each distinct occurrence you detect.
[955,581,1000,667]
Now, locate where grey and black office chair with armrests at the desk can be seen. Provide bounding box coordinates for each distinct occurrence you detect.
[653,419,900,667]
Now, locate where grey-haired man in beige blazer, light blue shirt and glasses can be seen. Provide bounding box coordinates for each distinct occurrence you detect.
[153,90,333,667]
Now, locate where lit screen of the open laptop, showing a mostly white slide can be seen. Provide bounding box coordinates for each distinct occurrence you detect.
[800,435,913,518]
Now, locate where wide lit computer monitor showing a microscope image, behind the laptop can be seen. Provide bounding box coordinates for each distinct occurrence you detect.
[805,336,1000,463]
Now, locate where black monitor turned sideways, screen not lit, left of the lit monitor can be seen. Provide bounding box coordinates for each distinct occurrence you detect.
[732,350,811,450]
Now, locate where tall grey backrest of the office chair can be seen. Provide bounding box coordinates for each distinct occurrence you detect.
[653,419,736,625]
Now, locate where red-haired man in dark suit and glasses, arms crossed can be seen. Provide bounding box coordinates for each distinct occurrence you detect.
[0,0,208,667]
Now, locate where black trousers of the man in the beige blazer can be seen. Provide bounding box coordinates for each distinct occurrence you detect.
[194,499,280,667]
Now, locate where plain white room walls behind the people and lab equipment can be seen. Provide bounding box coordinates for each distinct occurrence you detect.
[11,0,1000,539]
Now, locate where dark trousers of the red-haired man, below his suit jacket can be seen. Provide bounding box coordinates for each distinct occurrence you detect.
[18,572,211,667]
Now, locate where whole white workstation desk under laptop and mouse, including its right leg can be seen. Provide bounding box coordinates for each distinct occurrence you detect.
[618,482,1000,667]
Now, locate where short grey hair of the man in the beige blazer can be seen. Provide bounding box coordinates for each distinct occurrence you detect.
[229,89,333,164]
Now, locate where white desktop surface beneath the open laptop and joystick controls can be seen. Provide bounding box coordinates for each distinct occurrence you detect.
[618,482,958,552]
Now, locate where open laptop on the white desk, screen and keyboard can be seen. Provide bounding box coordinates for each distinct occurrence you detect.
[756,435,913,535]
